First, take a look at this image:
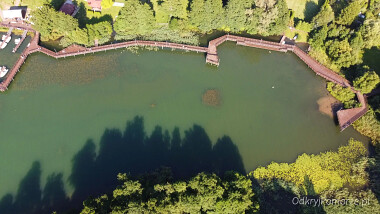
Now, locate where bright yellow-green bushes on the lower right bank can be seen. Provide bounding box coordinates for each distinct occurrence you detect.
[250,139,366,194]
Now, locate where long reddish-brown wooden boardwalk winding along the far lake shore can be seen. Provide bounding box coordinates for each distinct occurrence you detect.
[0,23,368,131]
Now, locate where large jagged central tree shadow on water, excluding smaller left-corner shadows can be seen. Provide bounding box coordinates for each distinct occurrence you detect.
[70,117,245,206]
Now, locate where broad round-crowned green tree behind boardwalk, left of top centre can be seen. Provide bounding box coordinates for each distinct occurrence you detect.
[114,0,155,38]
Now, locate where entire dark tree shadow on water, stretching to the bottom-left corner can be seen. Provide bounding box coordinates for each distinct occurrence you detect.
[0,117,245,214]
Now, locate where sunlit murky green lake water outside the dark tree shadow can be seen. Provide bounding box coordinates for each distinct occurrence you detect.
[0,43,366,197]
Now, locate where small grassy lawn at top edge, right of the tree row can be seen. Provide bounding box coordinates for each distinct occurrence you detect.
[286,0,324,21]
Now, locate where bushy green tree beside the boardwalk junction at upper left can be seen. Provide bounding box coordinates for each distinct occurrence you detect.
[32,5,78,41]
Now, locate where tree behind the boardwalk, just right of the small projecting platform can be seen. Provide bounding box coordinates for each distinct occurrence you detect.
[224,0,252,32]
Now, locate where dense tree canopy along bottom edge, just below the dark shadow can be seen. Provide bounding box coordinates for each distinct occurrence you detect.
[81,172,258,214]
